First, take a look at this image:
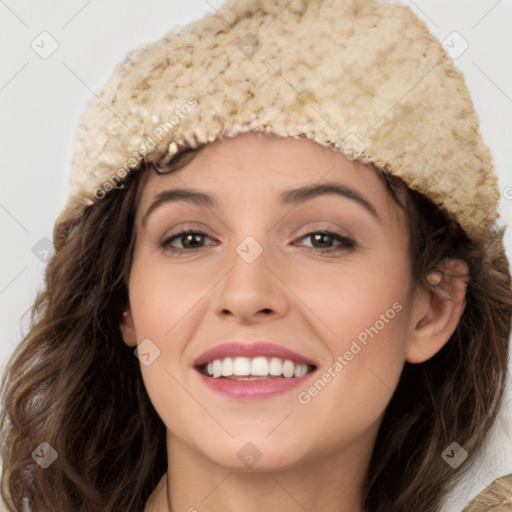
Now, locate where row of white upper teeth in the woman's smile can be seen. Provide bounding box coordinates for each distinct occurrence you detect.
[205,356,308,380]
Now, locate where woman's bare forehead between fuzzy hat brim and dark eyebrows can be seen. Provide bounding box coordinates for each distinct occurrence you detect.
[139,132,408,228]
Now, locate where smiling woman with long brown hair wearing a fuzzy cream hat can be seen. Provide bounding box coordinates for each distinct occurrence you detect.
[2,1,512,512]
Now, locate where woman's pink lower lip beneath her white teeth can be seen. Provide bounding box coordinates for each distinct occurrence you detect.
[199,371,315,400]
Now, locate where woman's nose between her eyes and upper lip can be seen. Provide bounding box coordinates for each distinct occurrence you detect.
[215,239,289,324]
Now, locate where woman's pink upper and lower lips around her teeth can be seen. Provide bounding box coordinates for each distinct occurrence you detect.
[194,341,318,400]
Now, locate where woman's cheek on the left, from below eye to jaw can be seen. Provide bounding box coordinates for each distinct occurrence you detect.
[129,255,218,424]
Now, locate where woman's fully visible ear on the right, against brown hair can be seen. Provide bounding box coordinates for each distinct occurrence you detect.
[405,258,469,363]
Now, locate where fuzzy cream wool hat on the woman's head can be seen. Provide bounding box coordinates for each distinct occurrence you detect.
[53,0,508,276]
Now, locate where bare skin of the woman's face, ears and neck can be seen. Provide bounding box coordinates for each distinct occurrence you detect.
[120,133,467,512]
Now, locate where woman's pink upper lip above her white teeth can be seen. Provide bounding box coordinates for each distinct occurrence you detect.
[194,341,317,366]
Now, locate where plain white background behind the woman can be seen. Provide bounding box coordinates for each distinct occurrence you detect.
[0,0,512,512]
